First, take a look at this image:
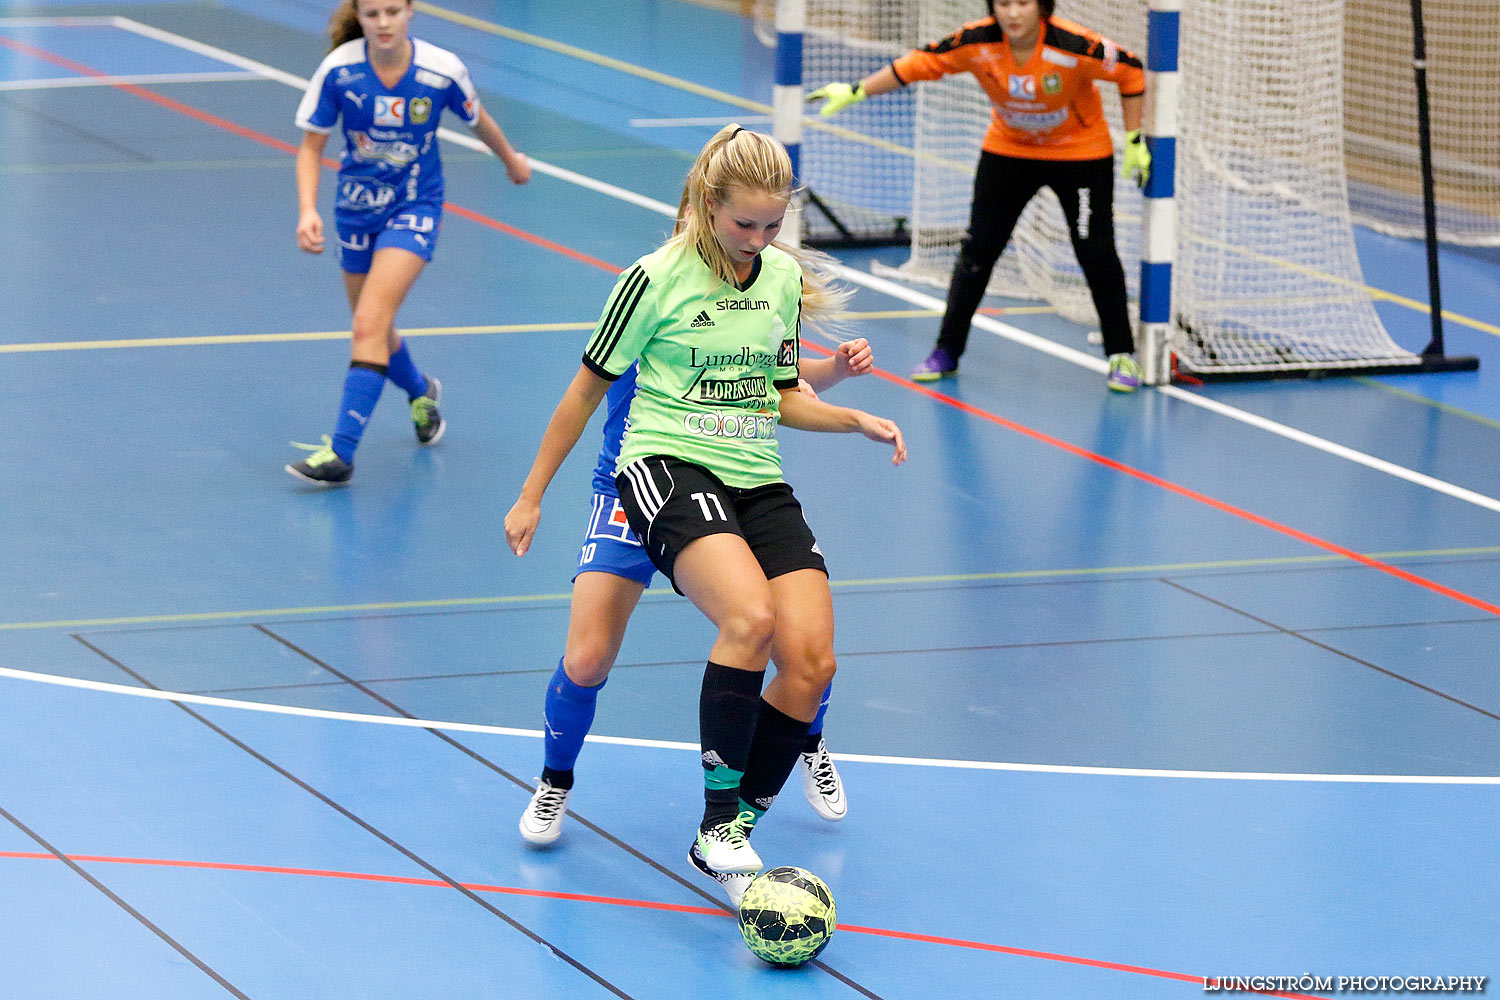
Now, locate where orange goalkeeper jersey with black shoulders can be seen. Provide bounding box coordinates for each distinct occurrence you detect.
[891,16,1146,160]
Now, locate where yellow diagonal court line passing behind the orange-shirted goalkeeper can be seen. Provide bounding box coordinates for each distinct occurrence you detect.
[417,0,1500,336]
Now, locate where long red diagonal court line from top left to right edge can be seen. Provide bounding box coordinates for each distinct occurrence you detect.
[0,36,1500,616]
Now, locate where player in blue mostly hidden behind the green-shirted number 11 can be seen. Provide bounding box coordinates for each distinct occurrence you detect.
[521,337,875,846]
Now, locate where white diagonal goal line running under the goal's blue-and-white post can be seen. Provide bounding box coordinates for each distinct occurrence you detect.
[73,16,1500,514]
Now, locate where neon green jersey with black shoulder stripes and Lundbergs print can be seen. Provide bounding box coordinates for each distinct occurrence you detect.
[584,244,803,489]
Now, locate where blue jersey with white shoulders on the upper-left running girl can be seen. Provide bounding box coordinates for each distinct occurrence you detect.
[297,37,480,229]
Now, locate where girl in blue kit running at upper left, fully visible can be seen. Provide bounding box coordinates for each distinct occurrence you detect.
[287,0,531,486]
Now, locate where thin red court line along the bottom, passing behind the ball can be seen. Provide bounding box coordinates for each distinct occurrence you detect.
[0,850,1325,1000]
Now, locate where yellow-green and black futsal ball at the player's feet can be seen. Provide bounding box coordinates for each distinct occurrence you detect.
[740,868,839,967]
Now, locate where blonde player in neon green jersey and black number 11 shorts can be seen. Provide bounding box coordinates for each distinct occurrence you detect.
[506,126,906,901]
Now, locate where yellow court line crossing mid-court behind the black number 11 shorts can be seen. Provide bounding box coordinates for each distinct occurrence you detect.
[0,546,1500,631]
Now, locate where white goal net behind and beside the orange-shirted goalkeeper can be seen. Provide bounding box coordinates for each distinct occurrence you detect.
[764,0,1494,376]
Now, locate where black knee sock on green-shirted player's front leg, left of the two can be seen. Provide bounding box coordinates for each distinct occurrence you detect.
[698,660,765,829]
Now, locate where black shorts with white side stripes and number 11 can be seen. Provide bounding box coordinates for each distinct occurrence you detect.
[615,454,828,594]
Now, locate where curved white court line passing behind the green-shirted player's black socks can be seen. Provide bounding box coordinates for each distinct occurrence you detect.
[0,667,1500,786]
